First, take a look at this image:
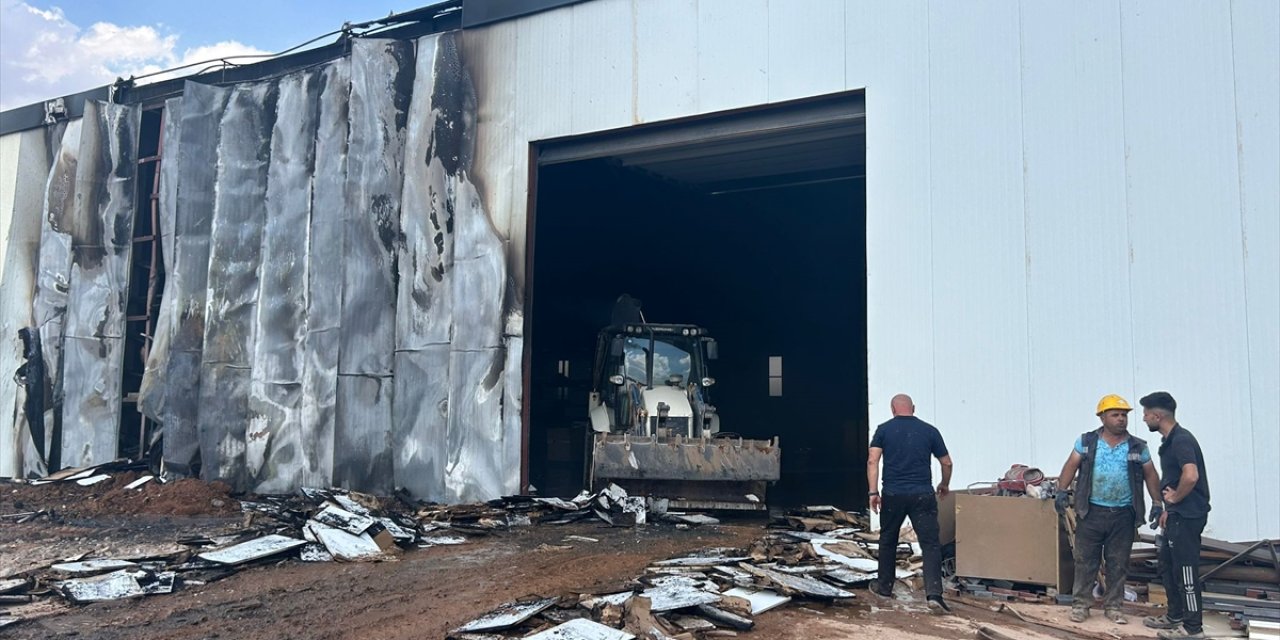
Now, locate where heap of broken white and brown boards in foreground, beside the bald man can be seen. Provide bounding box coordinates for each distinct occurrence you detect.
[449,507,919,640]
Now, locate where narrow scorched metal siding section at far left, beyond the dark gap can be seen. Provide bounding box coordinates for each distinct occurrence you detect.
[19,102,142,471]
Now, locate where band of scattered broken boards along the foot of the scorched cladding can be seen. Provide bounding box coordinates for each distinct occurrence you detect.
[0,461,752,623]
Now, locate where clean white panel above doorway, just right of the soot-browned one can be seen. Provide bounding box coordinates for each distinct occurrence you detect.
[570,0,635,133]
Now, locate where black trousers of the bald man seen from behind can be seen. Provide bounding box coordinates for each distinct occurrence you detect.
[879,493,942,598]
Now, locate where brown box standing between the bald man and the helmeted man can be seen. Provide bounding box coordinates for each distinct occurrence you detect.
[957,493,1075,593]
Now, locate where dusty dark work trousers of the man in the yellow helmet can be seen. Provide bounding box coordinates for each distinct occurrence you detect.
[1071,504,1137,609]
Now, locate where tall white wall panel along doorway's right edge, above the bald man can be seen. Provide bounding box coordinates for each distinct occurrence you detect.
[845,0,937,425]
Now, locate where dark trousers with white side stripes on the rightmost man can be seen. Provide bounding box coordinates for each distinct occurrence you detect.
[1158,513,1208,634]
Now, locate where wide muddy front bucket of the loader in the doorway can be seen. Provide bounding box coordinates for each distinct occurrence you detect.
[591,434,782,511]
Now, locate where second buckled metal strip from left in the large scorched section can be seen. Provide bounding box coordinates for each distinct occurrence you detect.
[200,82,276,486]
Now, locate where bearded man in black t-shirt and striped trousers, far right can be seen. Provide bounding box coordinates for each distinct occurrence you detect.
[1139,392,1210,640]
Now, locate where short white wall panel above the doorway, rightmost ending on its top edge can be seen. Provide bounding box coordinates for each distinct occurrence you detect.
[768,0,845,102]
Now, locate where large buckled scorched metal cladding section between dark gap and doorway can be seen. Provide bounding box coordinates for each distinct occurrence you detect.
[126,33,522,502]
